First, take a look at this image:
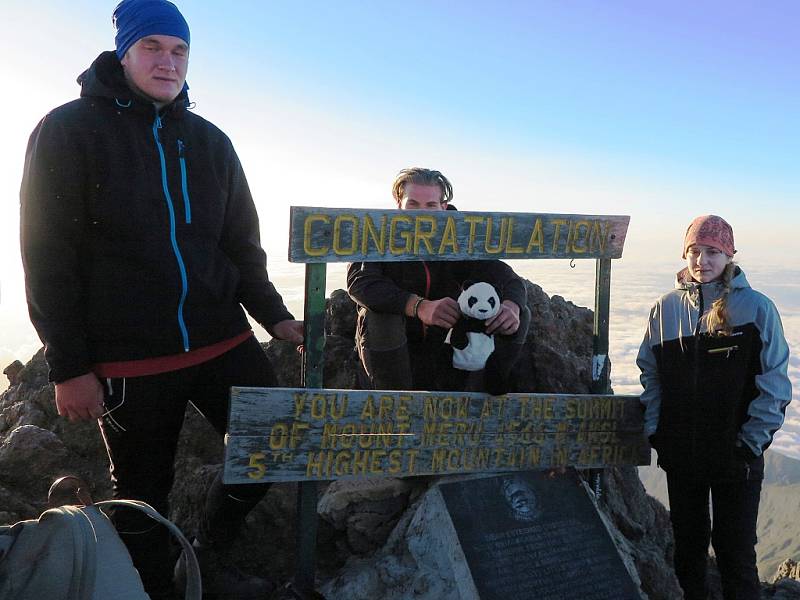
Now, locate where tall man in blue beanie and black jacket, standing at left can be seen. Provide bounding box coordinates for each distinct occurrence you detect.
[20,0,303,598]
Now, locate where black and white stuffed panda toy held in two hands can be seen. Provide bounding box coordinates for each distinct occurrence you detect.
[450,281,500,371]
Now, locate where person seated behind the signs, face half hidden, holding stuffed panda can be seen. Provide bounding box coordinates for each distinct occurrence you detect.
[347,167,530,394]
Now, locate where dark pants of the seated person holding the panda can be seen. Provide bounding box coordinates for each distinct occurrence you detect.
[356,306,531,393]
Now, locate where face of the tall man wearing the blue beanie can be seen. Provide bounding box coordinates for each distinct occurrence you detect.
[120,35,189,108]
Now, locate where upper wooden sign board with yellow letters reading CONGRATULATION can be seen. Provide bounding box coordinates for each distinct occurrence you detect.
[289,206,630,263]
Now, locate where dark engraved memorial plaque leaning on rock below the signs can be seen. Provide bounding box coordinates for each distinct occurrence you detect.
[439,469,641,600]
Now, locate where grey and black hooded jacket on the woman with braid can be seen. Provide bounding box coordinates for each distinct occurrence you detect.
[636,267,792,473]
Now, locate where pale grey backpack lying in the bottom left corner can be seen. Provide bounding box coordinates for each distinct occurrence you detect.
[0,500,202,600]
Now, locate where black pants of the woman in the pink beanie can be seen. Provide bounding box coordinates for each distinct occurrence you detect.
[667,466,763,600]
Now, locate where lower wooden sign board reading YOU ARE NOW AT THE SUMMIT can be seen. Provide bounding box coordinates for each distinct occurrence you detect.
[224,388,650,483]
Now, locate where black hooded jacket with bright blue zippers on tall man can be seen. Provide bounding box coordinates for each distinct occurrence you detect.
[20,52,292,382]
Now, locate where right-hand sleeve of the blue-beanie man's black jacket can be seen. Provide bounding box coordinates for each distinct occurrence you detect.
[220,142,294,333]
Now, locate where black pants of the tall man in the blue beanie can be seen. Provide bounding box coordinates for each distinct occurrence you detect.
[100,337,276,595]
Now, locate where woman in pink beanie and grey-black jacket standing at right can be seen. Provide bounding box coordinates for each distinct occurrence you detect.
[637,215,792,600]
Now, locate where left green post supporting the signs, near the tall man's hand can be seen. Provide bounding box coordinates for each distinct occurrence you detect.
[294,263,326,592]
